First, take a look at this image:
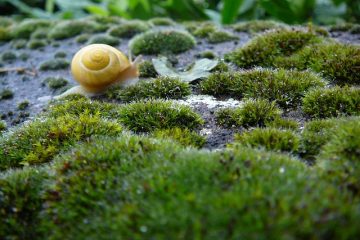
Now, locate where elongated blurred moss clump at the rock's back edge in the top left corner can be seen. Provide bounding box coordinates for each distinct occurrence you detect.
[10,19,53,39]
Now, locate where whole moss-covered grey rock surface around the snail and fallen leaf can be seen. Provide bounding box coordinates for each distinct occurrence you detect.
[0,17,360,239]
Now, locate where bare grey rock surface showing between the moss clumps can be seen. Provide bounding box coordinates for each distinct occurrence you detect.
[0,29,360,149]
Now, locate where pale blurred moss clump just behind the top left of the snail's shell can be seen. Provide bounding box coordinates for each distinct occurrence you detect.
[48,20,102,39]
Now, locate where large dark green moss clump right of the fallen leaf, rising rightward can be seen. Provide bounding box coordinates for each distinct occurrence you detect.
[226,30,322,68]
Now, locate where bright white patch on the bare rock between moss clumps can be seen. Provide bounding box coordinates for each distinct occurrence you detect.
[178,95,242,108]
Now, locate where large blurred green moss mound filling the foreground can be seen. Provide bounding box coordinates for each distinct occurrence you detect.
[35,136,360,239]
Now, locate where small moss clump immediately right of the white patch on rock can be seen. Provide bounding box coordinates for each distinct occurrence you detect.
[215,99,281,128]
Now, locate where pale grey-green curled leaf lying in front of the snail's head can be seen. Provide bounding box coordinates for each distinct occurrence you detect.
[152,57,219,82]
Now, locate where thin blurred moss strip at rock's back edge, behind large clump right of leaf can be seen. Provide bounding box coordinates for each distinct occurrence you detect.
[231,20,285,33]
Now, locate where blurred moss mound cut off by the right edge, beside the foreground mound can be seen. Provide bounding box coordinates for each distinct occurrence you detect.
[317,119,360,196]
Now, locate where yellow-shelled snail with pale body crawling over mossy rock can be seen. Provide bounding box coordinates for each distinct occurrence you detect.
[55,44,140,98]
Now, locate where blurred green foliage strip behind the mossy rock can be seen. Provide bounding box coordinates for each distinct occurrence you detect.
[0,0,360,24]
